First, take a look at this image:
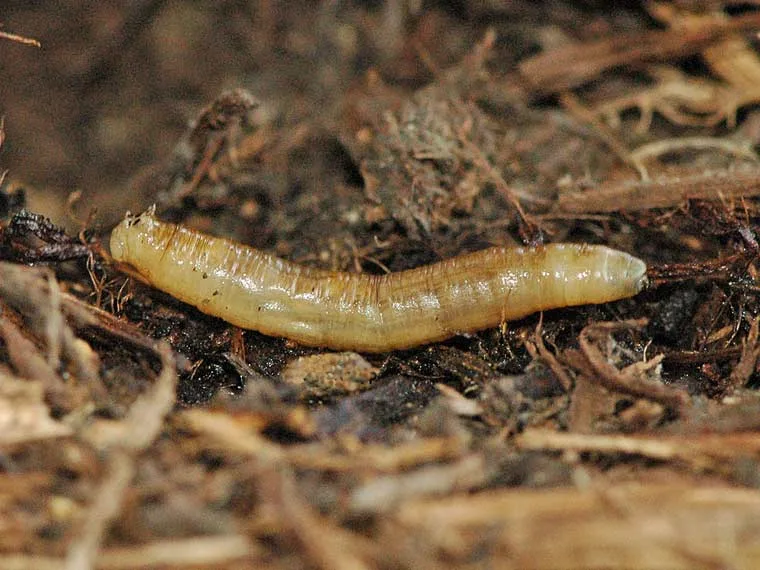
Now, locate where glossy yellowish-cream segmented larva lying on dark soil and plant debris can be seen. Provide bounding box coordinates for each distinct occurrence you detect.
[111,211,646,352]
